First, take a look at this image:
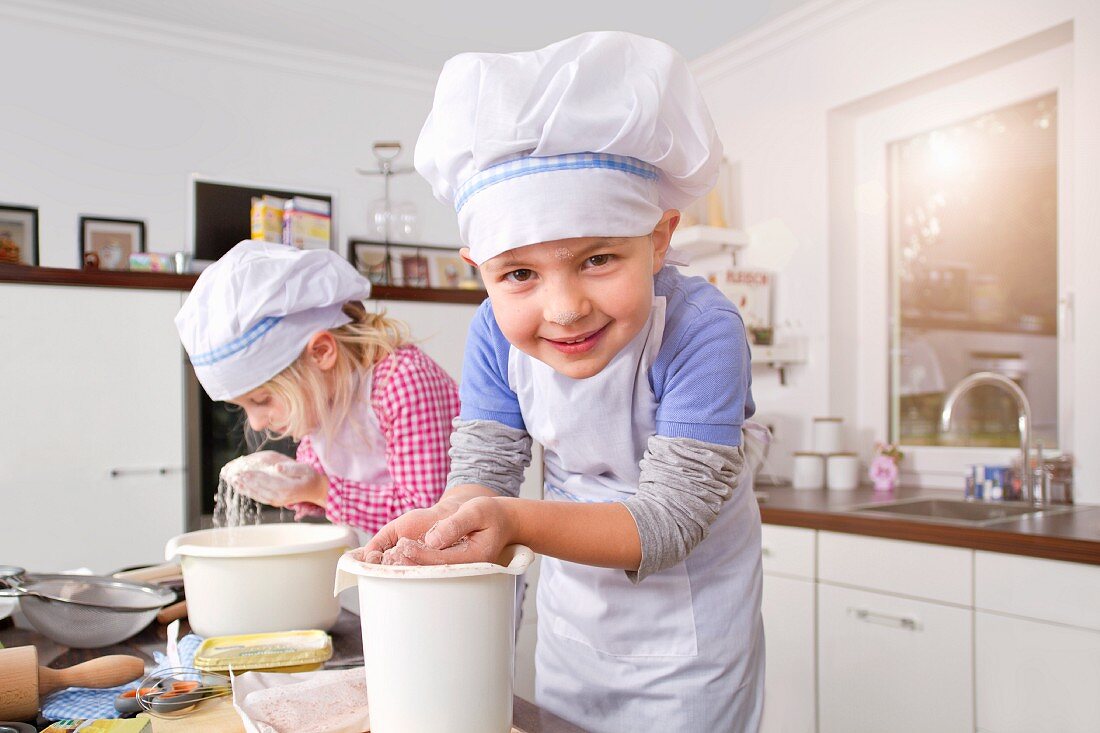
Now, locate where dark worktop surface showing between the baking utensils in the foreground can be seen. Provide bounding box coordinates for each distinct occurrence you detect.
[0,611,584,733]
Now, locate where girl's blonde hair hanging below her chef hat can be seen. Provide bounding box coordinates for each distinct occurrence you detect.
[264,300,409,441]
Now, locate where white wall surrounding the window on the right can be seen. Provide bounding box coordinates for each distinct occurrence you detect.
[694,0,1100,502]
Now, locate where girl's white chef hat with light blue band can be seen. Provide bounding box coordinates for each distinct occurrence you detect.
[176,240,371,401]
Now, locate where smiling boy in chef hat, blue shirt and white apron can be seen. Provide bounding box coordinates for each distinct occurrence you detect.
[363,33,763,733]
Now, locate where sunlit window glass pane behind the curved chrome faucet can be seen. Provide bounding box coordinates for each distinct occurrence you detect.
[886,94,1058,448]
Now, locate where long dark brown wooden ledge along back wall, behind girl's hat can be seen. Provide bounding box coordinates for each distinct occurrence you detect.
[0,264,486,305]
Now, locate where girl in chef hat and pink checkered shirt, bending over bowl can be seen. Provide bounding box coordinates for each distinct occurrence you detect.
[176,240,459,533]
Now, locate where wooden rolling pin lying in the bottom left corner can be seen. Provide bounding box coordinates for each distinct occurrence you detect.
[0,646,145,720]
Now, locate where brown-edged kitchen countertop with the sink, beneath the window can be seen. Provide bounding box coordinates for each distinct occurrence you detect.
[757,485,1100,565]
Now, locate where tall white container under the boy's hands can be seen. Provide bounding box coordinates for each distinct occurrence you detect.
[336,545,535,733]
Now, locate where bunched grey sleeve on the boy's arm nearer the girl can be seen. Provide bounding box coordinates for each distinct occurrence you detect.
[447,417,531,496]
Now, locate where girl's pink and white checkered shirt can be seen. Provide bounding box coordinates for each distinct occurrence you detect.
[292,346,459,533]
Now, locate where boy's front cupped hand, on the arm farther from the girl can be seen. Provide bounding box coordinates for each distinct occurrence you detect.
[385,496,513,565]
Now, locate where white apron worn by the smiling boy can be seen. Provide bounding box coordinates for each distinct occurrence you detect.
[508,297,763,733]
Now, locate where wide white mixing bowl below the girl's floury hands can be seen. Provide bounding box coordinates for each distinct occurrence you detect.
[164,524,356,637]
